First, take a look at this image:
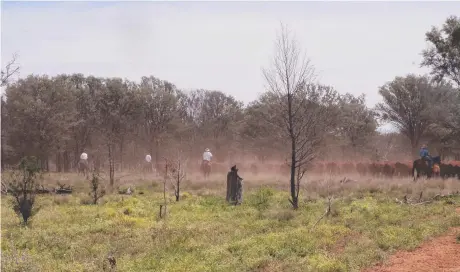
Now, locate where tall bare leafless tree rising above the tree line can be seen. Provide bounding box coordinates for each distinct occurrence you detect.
[263,25,337,209]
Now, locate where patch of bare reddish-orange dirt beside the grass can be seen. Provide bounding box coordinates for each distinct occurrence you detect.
[364,208,460,272]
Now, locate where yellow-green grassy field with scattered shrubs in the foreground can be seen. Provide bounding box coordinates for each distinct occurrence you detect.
[1,174,460,272]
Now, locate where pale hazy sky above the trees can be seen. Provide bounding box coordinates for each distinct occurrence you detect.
[1,1,460,111]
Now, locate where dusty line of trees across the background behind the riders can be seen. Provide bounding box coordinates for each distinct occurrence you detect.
[1,16,460,183]
